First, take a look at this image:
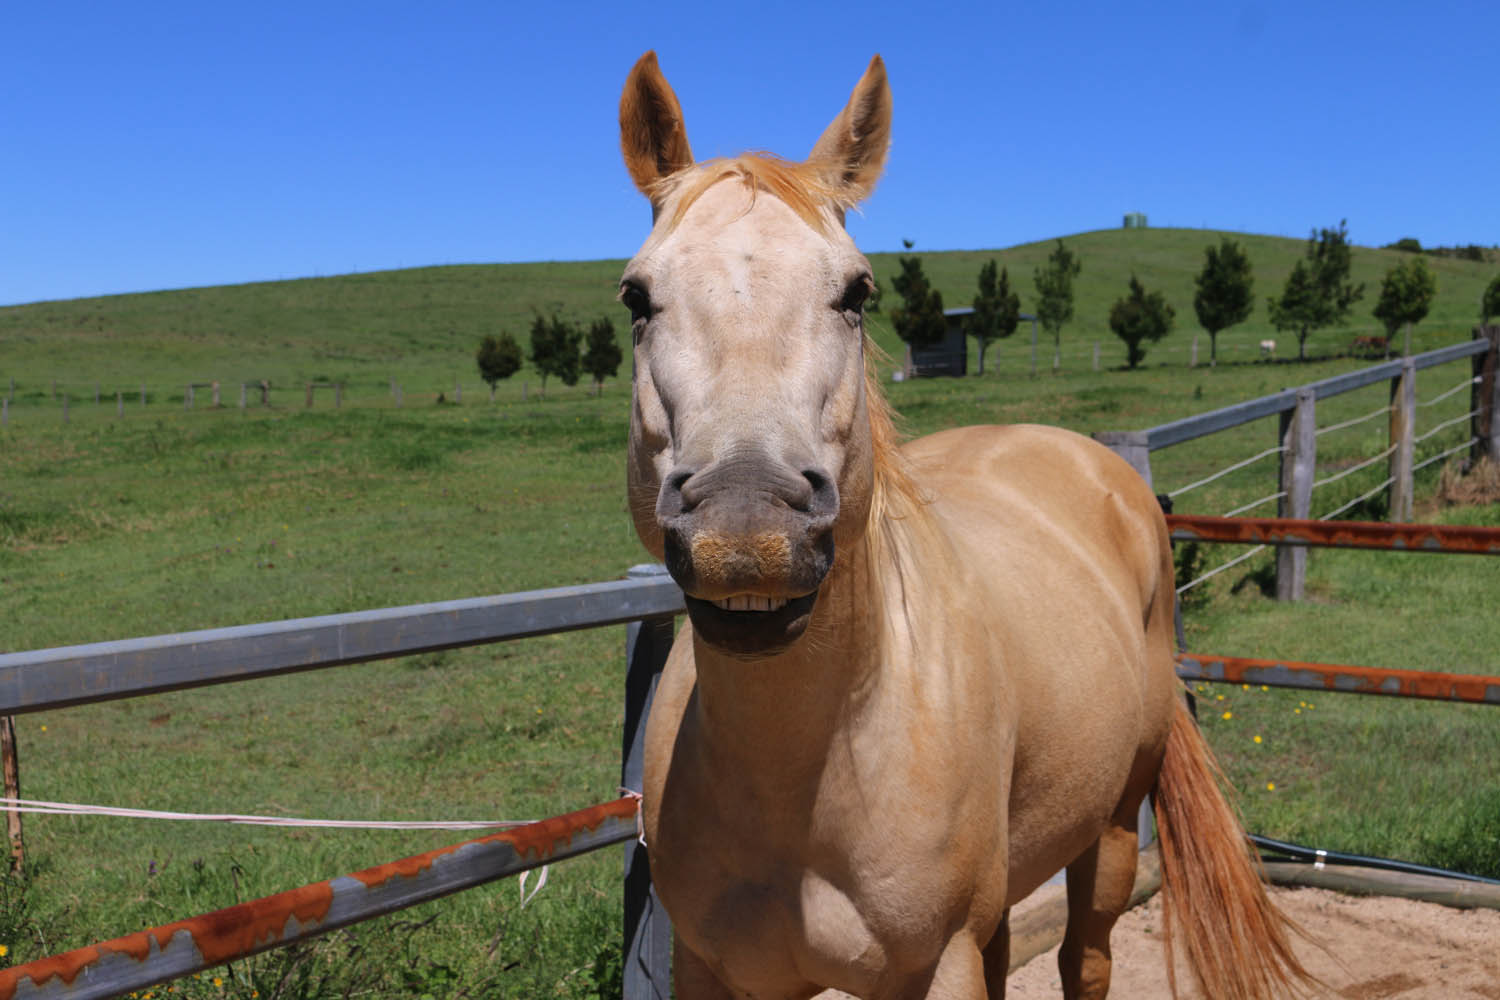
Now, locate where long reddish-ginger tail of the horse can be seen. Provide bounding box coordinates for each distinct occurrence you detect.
[1152,702,1317,1000]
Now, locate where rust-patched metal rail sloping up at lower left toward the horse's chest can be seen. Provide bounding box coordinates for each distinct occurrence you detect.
[0,798,636,1000]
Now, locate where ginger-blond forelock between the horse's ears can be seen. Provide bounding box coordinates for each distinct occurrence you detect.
[648,153,854,235]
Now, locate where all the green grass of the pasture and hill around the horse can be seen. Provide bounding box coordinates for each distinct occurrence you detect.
[0,231,1500,997]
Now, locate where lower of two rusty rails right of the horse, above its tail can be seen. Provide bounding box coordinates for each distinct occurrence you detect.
[1178,652,1500,705]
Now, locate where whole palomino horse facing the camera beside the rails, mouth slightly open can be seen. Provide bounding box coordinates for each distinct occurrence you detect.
[620,52,1305,1000]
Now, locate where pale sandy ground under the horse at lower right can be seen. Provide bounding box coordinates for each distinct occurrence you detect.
[1005,889,1500,1000]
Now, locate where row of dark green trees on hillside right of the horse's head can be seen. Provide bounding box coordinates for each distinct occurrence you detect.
[890,222,1500,375]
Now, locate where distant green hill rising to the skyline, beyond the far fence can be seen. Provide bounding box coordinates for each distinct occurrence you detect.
[0,229,1497,400]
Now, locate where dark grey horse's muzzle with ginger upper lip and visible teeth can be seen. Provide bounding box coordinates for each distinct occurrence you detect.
[657,451,839,658]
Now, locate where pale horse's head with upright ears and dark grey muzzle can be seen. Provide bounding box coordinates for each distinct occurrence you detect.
[620,52,891,657]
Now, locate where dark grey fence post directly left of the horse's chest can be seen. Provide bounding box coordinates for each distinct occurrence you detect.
[620,565,674,1000]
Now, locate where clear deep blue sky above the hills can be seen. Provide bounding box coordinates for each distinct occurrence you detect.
[0,0,1500,304]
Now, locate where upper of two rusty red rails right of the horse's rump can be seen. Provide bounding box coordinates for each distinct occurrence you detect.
[1167,514,1500,556]
